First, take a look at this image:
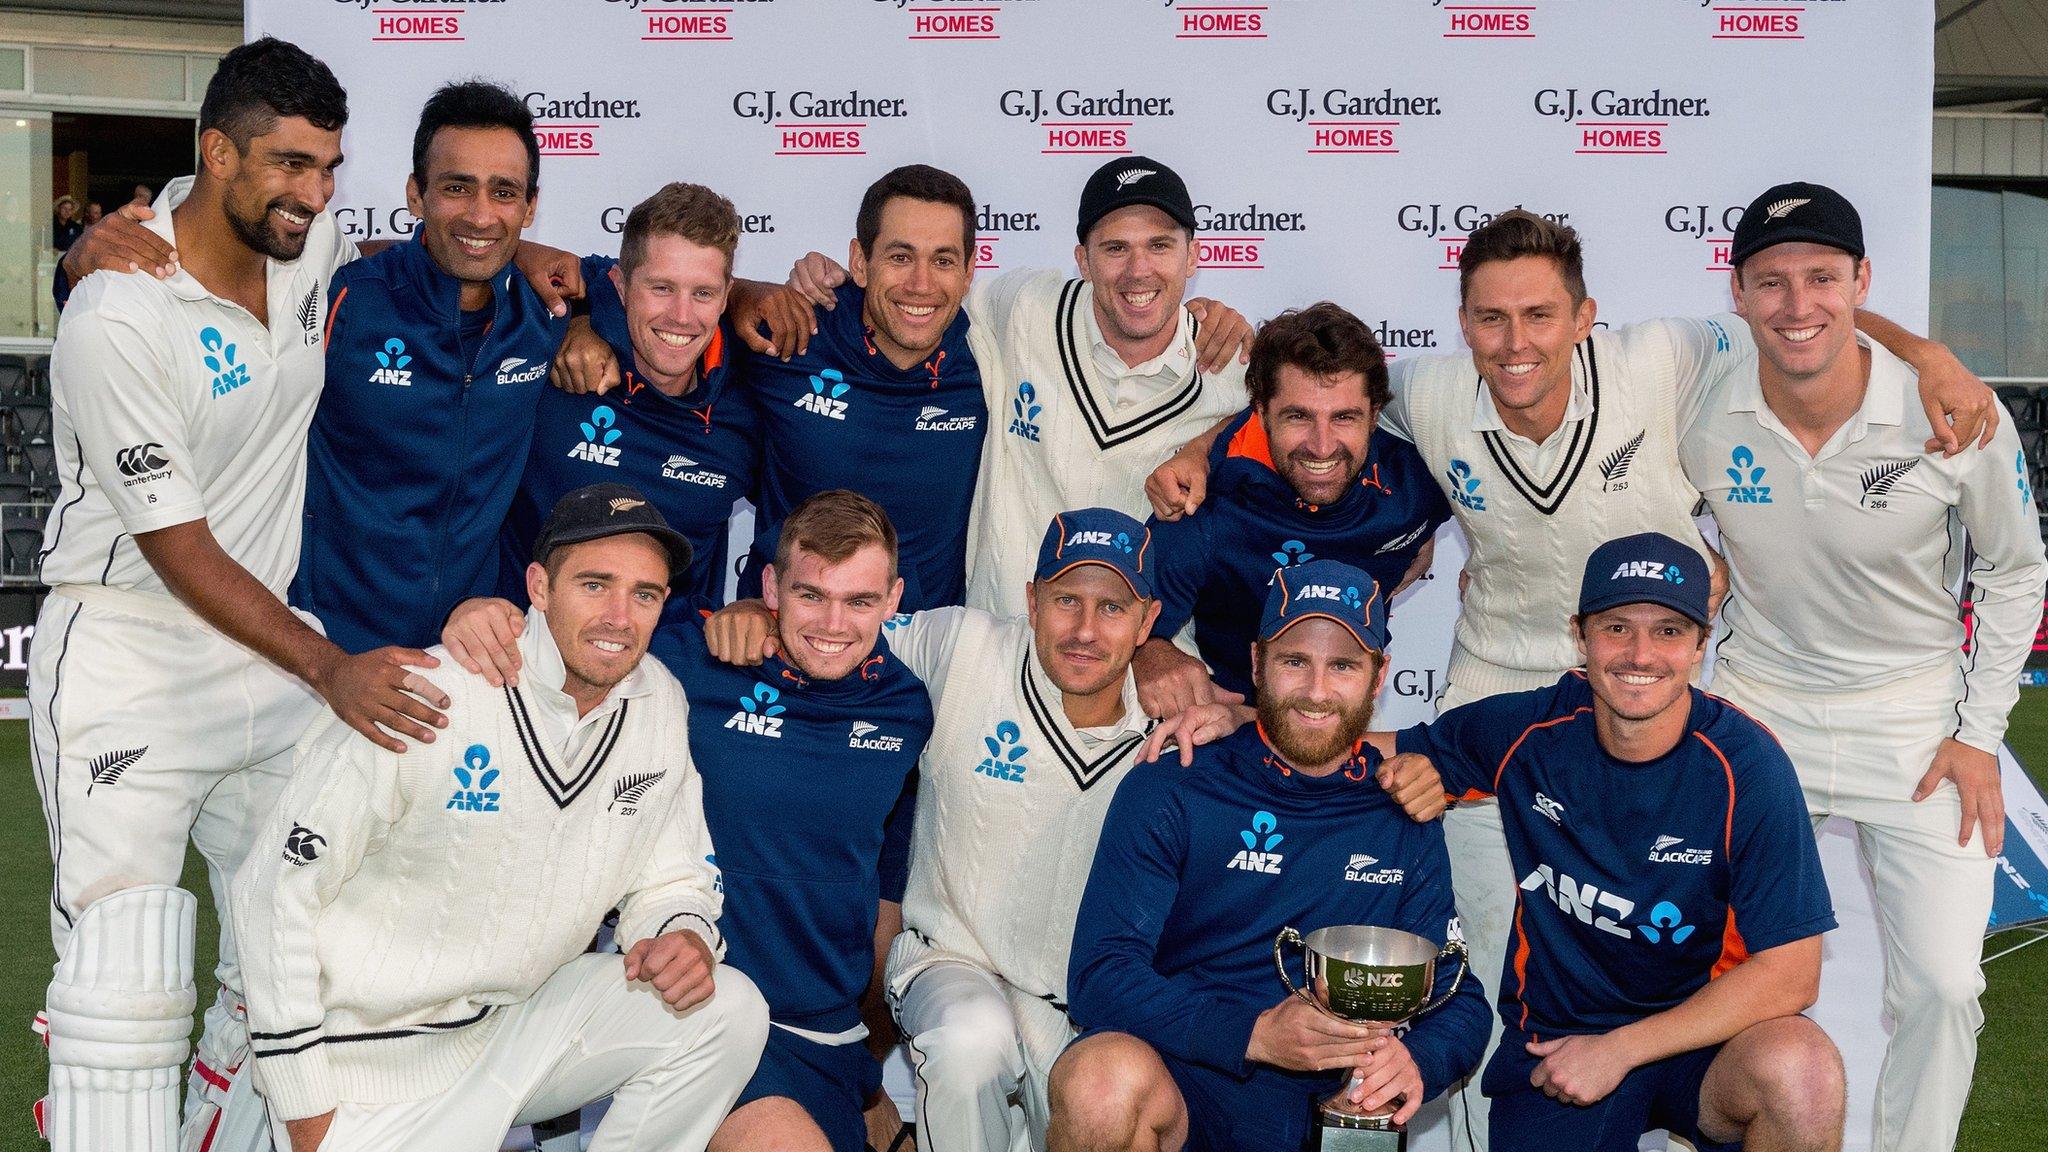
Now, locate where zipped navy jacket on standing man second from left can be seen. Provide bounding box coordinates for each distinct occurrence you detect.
[291,236,567,652]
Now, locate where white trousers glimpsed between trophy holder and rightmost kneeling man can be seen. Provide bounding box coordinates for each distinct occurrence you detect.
[1438,652,1565,1152]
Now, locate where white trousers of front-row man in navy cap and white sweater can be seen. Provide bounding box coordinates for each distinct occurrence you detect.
[889,933,1073,1152]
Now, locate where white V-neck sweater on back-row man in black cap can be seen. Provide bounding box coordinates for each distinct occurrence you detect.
[967,271,1245,619]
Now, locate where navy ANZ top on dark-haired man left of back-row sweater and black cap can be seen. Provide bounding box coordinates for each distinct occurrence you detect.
[739,281,989,613]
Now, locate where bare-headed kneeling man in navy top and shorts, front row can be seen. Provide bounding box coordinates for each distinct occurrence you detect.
[446,485,932,1152]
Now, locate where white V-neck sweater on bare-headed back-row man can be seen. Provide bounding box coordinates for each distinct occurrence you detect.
[1386,318,1749,695]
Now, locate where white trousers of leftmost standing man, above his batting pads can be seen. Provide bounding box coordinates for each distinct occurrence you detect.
[29,584,324,1121]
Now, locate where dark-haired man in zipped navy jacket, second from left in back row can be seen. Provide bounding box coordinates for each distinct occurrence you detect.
[293,80,569,652]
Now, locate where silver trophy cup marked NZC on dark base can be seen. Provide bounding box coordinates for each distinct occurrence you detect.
[1274,924,1470,1152]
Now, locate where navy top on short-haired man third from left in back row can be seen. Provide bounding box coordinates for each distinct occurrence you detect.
[498,256,760,605]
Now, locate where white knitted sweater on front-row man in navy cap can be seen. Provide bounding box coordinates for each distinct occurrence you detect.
[889,607,1153,1009]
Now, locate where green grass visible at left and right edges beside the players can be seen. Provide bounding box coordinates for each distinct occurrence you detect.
[0,701,2048,1152]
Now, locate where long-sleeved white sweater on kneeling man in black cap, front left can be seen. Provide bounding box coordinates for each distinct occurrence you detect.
[233,611,721,1119]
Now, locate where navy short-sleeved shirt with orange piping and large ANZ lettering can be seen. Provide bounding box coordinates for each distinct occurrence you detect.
[1397,670,1835,1035]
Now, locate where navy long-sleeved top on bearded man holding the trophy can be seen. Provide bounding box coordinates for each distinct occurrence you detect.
[1067,726,1487,1117]
